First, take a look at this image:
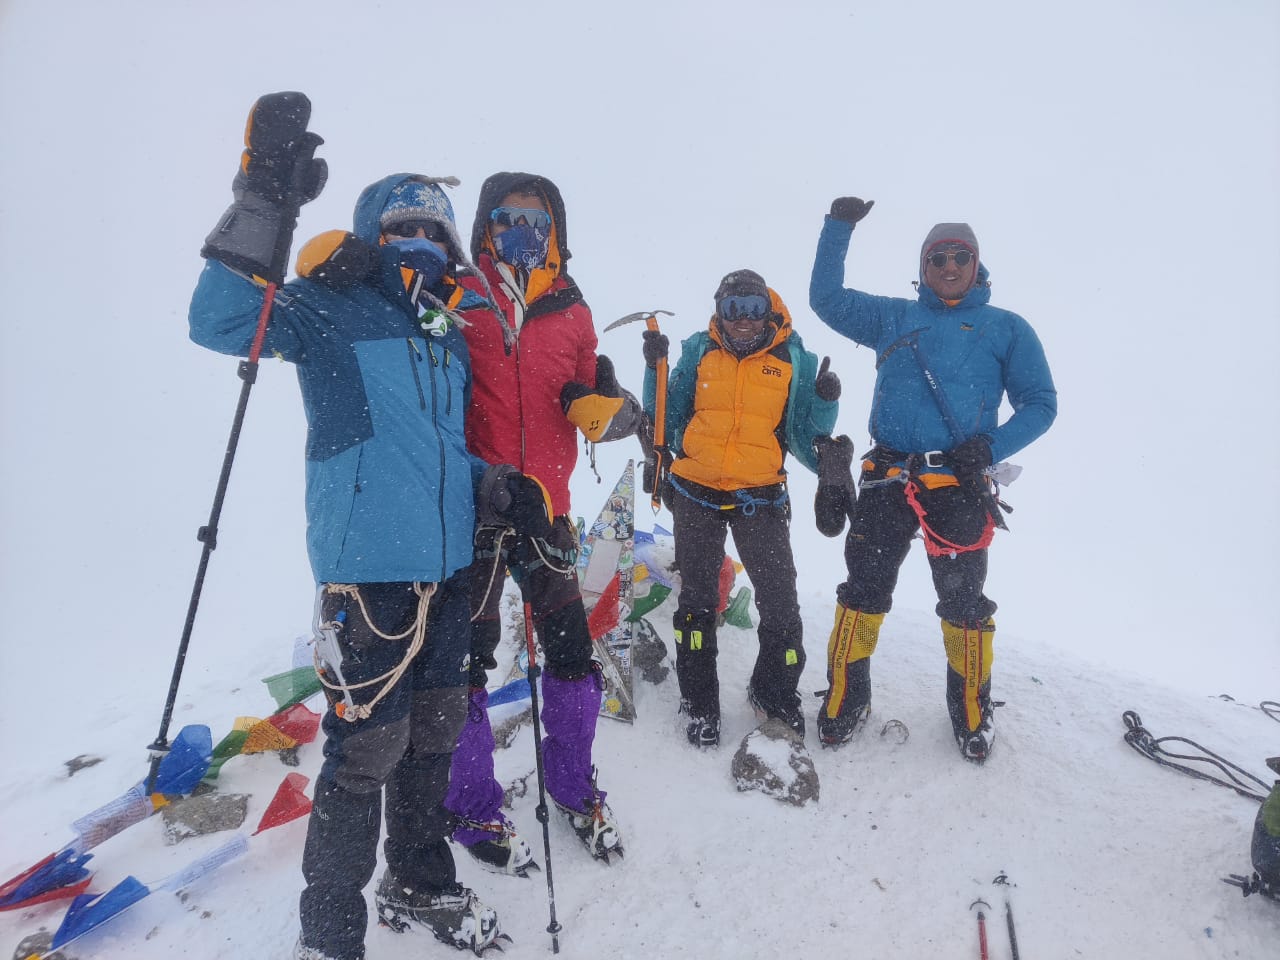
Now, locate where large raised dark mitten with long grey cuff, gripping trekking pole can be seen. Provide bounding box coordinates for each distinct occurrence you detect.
[200,92,329,283]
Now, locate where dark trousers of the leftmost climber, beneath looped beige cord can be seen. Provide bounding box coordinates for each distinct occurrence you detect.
[300,570,470,960]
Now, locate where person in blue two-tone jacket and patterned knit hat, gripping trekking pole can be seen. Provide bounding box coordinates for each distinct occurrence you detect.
[189,93,550,960]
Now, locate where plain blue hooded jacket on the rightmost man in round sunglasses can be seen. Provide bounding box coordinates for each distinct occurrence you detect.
[809,216,1057,462]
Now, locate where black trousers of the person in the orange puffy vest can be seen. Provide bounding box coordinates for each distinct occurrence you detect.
[672,480,805,717]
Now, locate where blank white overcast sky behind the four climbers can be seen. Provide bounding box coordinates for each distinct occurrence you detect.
[0,0,1280,752]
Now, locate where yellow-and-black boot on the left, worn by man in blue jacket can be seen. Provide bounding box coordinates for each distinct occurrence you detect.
[818,602,884,746]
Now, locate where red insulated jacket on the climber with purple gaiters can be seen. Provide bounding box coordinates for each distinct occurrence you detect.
[462,252,596,516]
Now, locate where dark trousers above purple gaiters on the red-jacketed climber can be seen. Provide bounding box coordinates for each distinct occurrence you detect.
[471,516,591,687]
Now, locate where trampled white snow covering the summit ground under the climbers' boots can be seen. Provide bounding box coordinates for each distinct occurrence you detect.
[0,576,1280,960]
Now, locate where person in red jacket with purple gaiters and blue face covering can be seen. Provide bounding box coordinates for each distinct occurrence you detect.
[445,173,640,876]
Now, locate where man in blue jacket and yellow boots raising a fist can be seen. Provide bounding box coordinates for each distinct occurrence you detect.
[809,197,1057,763]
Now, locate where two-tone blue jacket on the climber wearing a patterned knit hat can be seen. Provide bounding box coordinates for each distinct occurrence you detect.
[189,174,486,584]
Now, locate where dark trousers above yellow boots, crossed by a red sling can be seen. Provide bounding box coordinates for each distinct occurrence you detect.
[836,467,996,626]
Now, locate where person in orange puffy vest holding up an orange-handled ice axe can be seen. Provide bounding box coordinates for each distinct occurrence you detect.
[644,270,840,746]
